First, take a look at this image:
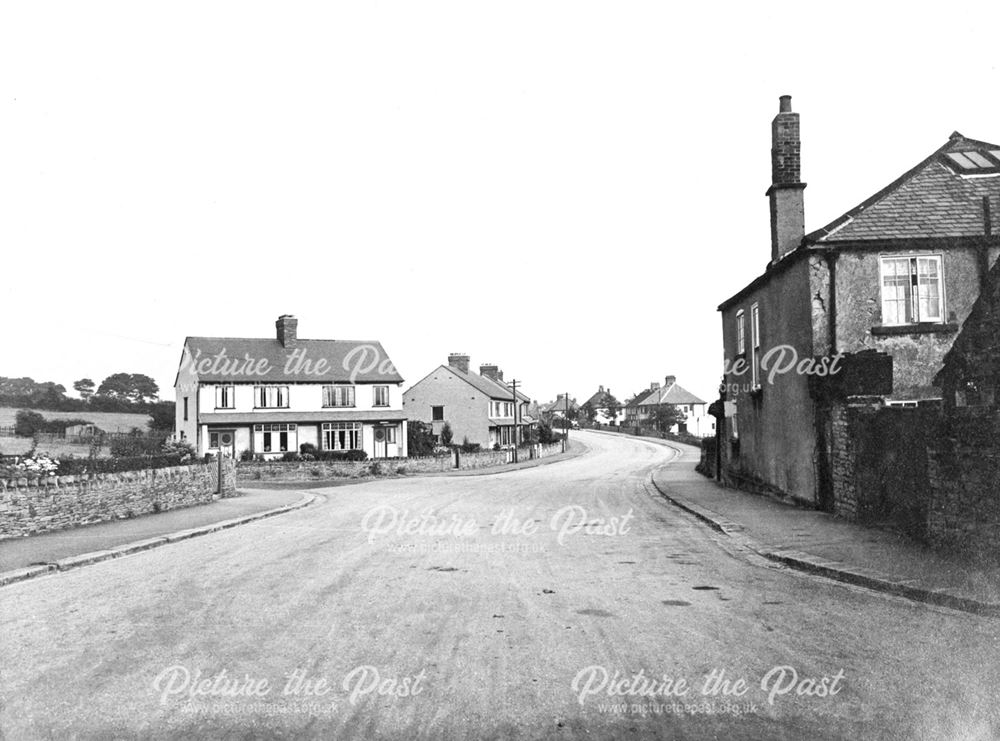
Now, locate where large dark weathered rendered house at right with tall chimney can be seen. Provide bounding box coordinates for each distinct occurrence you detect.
[719,96,1000,510]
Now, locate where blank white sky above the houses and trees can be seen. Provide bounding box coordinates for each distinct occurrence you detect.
[0,0,1000,402]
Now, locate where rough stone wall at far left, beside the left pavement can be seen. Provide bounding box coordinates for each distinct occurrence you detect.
[0,461,236,538]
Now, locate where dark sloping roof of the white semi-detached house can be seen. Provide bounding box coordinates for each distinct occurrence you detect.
[178,337,403,383]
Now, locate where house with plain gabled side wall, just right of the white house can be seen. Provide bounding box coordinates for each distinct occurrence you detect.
[403,354,536,448]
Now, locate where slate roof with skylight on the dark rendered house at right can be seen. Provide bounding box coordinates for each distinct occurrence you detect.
[806,132,1000,244]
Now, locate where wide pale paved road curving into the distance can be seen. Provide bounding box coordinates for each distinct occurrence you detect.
[0,434,1000,739]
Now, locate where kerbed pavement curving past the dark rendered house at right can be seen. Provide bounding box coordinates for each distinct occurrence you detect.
[616,430,1000,617]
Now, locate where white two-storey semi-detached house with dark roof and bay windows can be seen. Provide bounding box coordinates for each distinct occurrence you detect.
[175,314,407,458]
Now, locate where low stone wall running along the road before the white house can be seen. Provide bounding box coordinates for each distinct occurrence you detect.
[236,443,562,484]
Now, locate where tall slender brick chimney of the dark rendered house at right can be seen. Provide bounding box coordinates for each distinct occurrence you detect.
[767,95,806,263]
